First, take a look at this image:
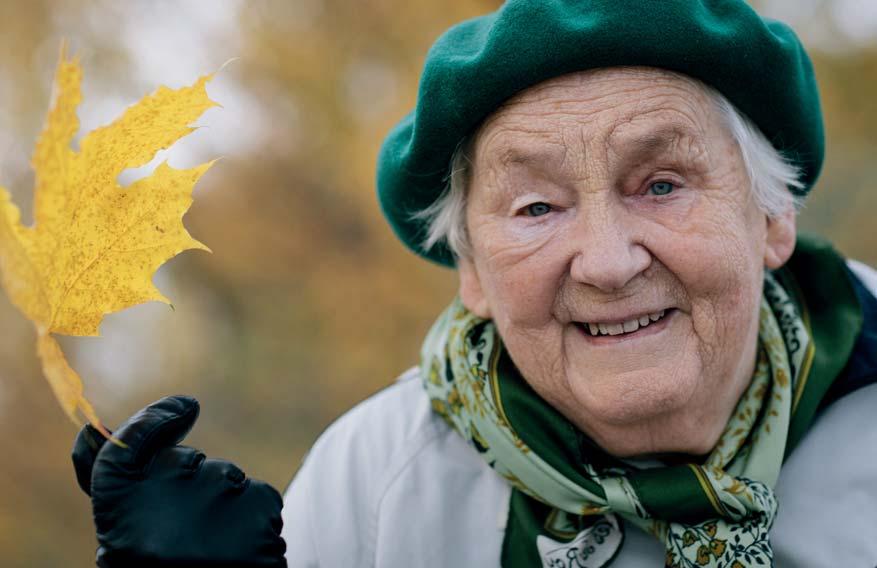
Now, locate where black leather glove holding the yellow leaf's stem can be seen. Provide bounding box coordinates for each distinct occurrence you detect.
[73,396,286,568]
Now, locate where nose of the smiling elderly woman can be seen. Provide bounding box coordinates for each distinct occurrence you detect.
[570,205,652,292]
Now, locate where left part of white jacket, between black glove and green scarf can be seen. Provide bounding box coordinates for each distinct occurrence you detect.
[283,369,511,568]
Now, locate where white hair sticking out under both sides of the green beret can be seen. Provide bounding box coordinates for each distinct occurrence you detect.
[411,84,804,258]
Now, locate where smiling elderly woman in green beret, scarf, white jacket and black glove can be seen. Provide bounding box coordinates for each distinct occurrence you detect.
[74,0,877,567]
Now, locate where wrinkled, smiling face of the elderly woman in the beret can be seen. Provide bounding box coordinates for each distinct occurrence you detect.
[459,68,795,457]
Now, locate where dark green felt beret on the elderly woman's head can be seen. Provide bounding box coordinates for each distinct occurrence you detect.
[377,0,825,266]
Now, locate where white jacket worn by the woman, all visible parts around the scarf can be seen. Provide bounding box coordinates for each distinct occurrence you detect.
[283,265,877,568]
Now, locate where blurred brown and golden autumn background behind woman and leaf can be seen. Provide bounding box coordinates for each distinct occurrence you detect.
[0,0,877,568]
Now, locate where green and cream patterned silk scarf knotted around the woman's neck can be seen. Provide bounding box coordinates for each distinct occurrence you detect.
[421,268,844,568]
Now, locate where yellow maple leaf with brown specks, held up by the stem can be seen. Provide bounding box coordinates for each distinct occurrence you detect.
[0,48,216,432]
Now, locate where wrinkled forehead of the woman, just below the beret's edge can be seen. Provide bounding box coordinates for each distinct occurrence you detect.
[474,67,720,162]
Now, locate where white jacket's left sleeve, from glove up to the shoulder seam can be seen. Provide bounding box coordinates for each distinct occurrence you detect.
[283,368,450,567]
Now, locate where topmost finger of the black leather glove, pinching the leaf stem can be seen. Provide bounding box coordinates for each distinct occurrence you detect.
[96,396,200,473]
